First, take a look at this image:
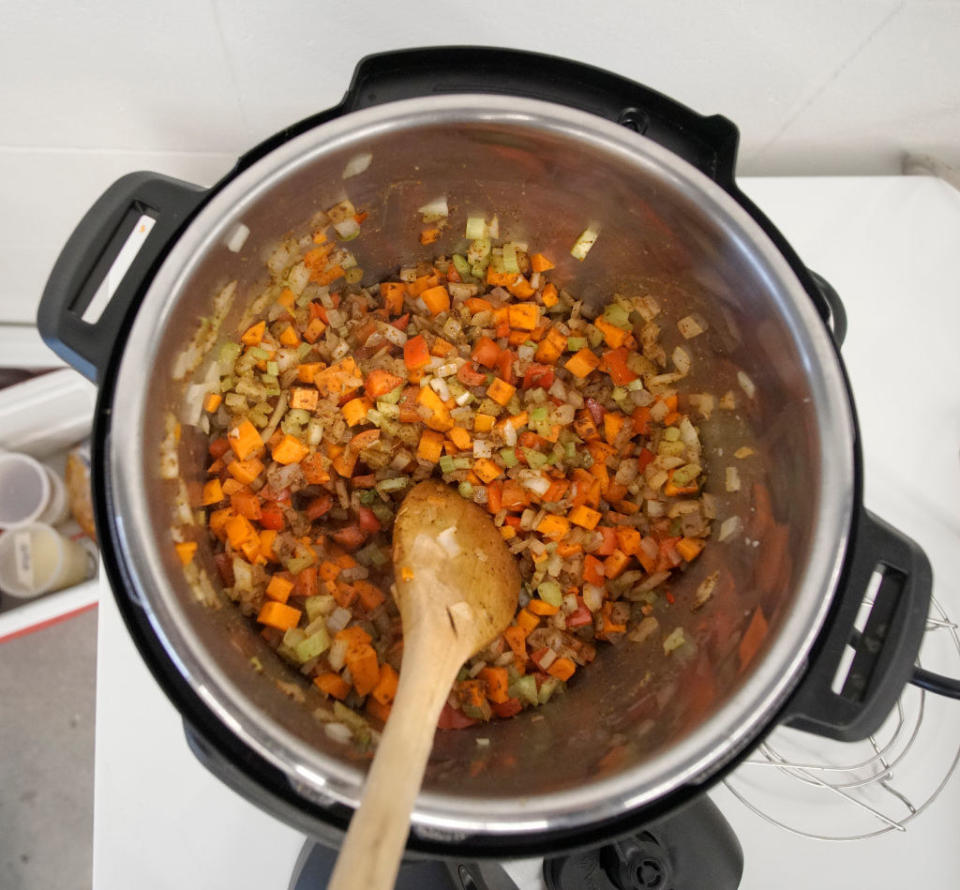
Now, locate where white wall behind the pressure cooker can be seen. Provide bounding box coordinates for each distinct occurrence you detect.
[0,0,960,321]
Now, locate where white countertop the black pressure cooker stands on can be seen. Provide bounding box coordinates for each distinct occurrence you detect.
[93,178,960,890]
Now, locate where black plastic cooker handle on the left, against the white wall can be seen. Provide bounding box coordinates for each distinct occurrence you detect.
[37,173,205,383]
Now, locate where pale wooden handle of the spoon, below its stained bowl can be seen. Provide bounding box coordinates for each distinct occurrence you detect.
[327,634,469,890]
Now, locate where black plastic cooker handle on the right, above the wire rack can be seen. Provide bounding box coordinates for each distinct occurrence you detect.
[783,510,933,742]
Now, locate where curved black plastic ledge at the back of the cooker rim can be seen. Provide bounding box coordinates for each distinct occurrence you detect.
[342,46,739,185]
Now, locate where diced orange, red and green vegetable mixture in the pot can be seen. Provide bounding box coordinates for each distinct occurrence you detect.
[197,201,712,728]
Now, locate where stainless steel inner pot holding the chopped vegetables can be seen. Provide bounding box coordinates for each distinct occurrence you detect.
[106,94,854,839]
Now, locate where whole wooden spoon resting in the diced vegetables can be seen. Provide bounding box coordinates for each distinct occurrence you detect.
[328,481,520,890]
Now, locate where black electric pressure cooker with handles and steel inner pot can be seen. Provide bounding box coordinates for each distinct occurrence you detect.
[38,47,944,888]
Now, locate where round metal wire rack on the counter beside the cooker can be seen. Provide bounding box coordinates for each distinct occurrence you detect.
[724,598,960,841]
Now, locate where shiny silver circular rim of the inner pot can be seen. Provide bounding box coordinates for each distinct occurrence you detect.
[104,94,855,840]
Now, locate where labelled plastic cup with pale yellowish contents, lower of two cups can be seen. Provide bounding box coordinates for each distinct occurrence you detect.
[0,522,96,598]
